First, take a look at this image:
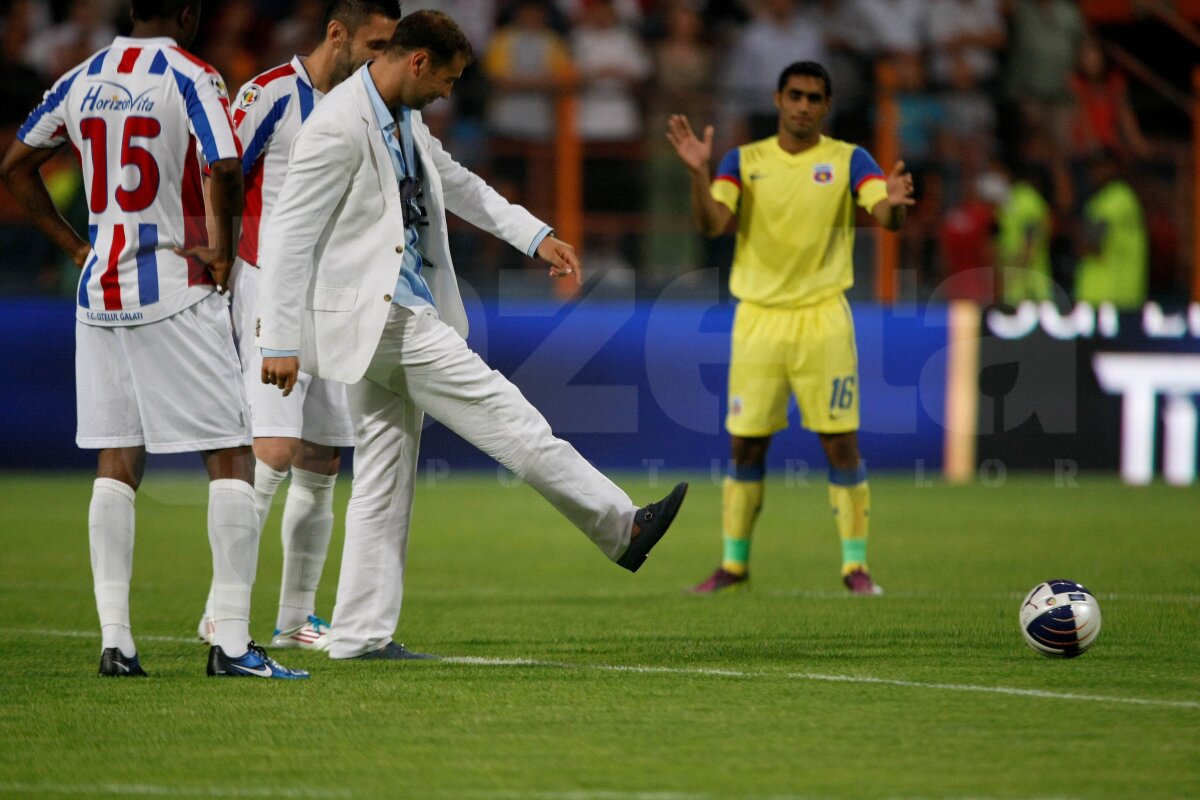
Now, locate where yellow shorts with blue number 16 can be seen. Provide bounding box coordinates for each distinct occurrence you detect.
[725,295,858,438]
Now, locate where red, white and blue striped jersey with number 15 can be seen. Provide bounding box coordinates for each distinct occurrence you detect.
[17,36,241,325]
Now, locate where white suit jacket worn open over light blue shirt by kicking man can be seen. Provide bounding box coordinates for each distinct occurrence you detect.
[257,67,546,384]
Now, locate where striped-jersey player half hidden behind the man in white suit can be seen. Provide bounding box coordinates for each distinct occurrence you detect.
[199,0,400,650]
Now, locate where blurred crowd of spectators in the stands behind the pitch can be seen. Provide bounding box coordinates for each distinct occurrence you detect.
[0,0,1190,306]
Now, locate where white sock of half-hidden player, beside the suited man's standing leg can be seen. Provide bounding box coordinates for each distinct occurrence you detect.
[275,468,337,631]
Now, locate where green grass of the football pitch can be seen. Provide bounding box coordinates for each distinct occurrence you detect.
[0,471,1200,800]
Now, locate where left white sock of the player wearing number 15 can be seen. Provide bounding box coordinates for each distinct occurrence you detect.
[88,477,138,657]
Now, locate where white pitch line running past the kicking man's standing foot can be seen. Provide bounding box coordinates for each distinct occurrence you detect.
[11,628,1200,709]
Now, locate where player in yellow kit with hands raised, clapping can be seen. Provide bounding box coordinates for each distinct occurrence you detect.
[667,61,916,595]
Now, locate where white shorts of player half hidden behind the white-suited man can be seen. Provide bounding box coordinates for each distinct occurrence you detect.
[226,259,354,447]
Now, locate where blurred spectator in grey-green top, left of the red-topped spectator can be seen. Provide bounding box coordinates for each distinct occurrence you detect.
[1007,0,1086,156]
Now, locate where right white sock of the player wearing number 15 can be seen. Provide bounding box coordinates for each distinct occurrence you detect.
[209,480,258,658]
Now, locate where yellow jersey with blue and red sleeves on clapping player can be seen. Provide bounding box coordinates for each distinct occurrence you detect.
[710,136,888,308]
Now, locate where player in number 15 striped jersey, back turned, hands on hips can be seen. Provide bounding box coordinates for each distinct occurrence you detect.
[0,0,308,679]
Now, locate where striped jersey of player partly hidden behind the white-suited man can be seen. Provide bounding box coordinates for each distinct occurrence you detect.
[233,55,324,266]
